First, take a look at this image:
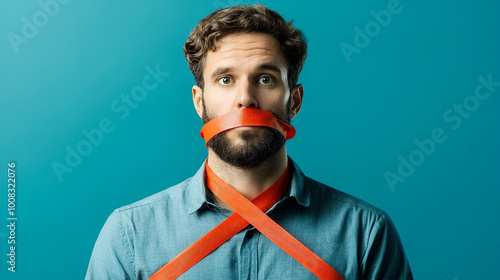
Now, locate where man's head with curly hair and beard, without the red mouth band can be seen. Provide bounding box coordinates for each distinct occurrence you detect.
[184,6,307,167]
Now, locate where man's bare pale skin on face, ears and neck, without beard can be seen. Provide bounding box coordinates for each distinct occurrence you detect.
[192,33,304,212]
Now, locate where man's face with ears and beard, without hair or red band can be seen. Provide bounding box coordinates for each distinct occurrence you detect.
[193,33,302,167]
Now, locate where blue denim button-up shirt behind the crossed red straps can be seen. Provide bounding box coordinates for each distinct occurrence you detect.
[85,158,413,280]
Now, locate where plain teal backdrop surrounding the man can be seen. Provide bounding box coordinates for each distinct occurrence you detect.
[0,0,500,280]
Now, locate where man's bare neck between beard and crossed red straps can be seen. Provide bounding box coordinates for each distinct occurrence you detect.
[208,145,288,212]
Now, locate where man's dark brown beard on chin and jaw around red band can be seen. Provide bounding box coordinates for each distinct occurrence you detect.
[202,97,291,168]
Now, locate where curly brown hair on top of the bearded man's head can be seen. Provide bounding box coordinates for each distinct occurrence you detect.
[184,4,307,90]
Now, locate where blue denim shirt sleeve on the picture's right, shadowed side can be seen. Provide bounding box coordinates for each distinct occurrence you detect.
[360,215,413,280]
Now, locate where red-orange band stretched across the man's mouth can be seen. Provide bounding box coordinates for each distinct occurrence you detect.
[200,108,295,146]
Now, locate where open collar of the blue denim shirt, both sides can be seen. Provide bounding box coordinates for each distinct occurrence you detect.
[184,157,311,214]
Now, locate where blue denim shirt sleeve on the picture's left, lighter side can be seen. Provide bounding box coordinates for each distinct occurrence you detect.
[85,212,135,280]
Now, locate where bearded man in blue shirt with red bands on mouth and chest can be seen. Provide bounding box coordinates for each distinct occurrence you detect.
[86,5,413,280]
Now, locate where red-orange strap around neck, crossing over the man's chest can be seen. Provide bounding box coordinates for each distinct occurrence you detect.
[149,163,344,280]
